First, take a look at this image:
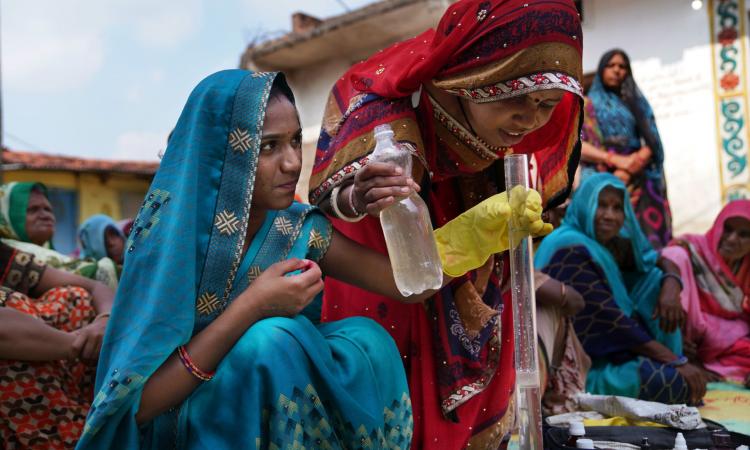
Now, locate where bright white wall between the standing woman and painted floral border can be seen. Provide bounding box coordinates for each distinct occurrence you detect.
[583,0,721,234]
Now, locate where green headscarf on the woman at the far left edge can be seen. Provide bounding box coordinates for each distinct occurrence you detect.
[0,182,52,247]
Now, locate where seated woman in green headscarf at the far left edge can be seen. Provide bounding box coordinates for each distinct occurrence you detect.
[0,182,117,289]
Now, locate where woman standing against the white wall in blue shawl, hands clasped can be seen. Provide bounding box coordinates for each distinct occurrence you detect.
[581,49,672,249]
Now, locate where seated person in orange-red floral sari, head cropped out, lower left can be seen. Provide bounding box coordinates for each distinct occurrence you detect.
[0,242,114,449]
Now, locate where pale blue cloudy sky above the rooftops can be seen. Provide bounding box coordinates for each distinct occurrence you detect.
[0,0,372,160]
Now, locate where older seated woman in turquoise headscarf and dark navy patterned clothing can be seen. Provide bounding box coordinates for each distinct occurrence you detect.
[535,173,706,404]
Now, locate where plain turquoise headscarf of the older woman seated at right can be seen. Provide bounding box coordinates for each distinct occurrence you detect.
[534,172,659,316]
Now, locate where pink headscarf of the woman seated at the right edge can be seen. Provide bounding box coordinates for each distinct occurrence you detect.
[672,200,750,319]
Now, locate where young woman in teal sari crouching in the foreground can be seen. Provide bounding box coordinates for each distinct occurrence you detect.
[79,70,544,449]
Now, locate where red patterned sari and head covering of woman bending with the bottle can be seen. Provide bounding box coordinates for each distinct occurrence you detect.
[309,0,583,436]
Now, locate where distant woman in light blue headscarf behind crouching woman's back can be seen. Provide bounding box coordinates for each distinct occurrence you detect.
[78,214,125,265]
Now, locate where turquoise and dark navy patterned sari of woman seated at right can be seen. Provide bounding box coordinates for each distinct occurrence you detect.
[534,173,689,403]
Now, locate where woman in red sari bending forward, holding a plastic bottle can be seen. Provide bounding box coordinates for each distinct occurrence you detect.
[310,0,582,449]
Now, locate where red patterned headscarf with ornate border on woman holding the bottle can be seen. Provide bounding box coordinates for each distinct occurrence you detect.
[310,0,582,207]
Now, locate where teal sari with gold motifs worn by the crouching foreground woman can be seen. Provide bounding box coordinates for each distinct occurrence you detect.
[78,70,412,449]
